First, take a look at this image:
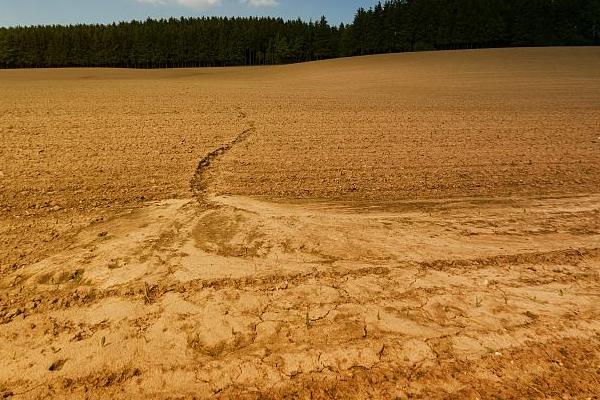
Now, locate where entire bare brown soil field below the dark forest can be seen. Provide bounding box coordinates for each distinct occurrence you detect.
[0,47,600,399]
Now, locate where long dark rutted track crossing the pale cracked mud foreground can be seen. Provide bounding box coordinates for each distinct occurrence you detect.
[0,248,600,325]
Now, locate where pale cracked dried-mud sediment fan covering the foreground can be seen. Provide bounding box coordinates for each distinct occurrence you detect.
[0,196,600,398]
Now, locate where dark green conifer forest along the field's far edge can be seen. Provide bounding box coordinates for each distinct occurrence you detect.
[0,0,600,68]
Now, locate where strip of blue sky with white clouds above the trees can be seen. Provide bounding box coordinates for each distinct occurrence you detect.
[0,0,377,26]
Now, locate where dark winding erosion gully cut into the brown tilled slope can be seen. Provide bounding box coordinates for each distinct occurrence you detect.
[190,111,256,206]
